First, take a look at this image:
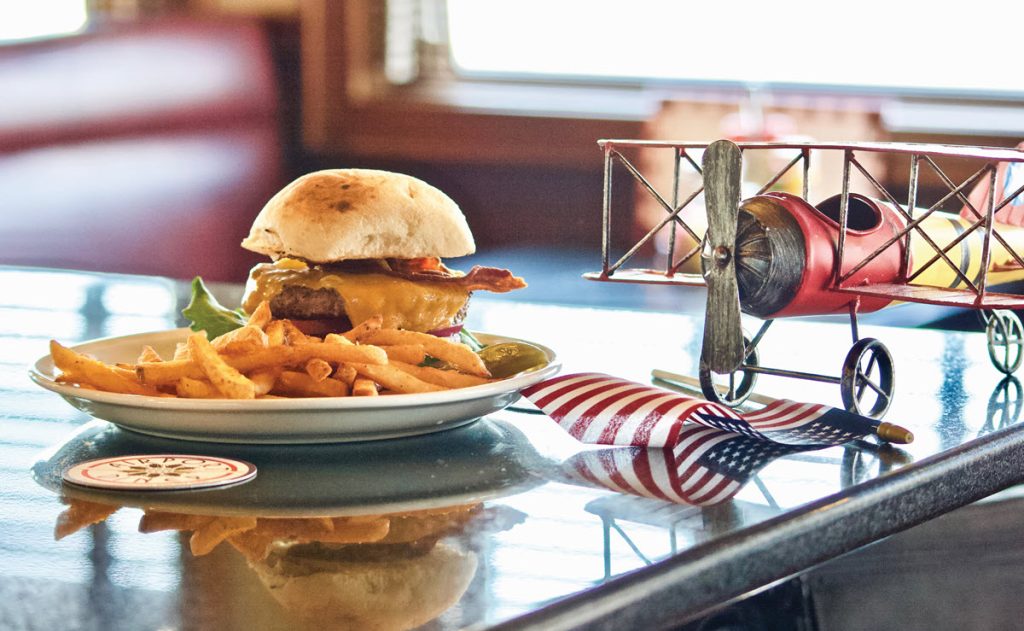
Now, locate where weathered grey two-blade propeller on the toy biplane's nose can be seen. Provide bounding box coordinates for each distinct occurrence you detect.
[700,140,744,374]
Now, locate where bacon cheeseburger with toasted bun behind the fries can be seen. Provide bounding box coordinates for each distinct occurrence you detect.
[242,169,526,337]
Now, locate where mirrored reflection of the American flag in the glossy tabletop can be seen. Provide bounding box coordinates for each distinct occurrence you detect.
[562,425,808,506]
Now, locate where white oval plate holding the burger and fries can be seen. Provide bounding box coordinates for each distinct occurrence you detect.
[29,329,561,444]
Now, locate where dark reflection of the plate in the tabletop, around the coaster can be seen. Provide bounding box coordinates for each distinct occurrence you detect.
[32,419,546,517]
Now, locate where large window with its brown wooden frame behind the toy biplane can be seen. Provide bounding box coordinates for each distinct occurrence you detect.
[300,0,1024,168]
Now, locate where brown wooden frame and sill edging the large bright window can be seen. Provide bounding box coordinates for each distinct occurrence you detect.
[299,0,1024,169]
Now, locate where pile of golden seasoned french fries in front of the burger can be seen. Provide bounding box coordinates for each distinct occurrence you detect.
[50,302,528,399]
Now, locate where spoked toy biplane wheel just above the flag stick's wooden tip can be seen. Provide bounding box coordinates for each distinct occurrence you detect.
[840,337,896,419]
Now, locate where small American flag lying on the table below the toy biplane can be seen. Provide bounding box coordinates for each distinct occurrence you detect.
[523,373,876,448]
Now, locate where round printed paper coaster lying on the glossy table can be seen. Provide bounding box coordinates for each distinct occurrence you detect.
[63,454,256,491]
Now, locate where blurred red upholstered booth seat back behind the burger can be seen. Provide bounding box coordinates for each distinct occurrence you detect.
[0,20,284,281]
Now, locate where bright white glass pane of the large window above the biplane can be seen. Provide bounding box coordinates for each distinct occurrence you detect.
[447,0,1024,96]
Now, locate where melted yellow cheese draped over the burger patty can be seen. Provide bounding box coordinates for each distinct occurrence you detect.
[243,259,469,331]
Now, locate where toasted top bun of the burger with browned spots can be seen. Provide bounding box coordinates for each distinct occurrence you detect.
[242,169,476,263]
